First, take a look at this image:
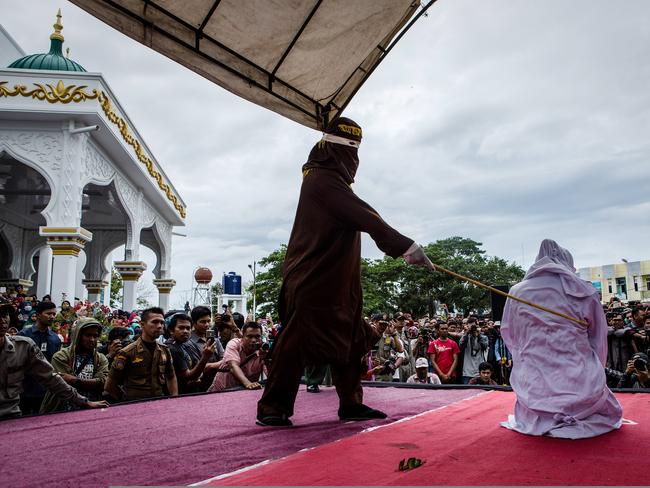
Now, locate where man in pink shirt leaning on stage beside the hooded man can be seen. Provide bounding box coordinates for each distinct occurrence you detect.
[208,322,269,392]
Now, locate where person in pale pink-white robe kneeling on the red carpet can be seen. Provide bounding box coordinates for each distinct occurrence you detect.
[501,239,622,439]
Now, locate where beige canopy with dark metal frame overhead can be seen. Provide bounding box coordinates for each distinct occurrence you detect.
[71,0,435,128]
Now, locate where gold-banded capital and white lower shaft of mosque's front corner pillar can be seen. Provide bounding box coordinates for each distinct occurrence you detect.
[39,227,93,305]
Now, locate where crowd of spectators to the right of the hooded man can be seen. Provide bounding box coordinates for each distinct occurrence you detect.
[365,300,650,388]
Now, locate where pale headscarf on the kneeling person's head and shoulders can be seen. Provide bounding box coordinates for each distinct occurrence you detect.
[524,239,598,298]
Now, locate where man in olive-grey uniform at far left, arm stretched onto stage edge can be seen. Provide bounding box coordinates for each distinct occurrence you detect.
[0,305,108,418]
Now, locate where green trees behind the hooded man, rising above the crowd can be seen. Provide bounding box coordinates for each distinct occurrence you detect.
[248,237,524,316]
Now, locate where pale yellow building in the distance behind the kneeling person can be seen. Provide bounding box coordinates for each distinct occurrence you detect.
[578,260,650,302]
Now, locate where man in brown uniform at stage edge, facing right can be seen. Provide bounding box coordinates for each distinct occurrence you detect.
[104,307,178,401]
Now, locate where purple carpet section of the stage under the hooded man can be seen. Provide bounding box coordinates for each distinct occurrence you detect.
[0,387,480,488]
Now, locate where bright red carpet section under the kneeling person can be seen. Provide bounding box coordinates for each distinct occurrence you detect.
[207,391,650,486]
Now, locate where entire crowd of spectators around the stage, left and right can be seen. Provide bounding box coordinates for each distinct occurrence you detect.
[0,287,650,418]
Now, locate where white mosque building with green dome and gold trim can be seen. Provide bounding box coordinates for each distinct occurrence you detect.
[0,12,186,310]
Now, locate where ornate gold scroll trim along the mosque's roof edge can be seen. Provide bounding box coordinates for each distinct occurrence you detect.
[0,80,187,218]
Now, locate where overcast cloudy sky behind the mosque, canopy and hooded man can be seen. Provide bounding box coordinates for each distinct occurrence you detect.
[0,0,650,305]
